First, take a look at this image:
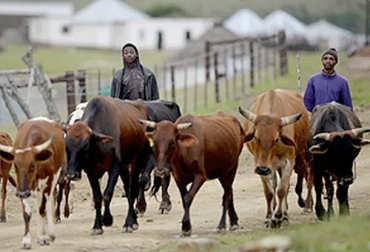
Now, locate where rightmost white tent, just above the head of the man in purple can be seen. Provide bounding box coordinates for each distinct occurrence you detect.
[307,19,354,50]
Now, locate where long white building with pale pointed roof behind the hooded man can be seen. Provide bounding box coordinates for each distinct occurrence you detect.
[29,0,213,50]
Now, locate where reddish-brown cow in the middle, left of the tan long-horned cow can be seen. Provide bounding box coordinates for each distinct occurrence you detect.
[141,111,244,236]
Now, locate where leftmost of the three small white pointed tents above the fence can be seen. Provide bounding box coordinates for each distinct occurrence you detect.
[224,9,263,37]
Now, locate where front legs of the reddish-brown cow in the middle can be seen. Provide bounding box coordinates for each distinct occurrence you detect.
[179,175,205,236]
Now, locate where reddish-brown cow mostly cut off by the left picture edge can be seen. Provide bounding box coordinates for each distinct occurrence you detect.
[0,132,17,222]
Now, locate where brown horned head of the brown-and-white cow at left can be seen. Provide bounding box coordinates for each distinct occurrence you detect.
[0,136,54,198]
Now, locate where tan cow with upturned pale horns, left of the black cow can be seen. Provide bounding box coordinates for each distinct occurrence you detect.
[239,89,309,228]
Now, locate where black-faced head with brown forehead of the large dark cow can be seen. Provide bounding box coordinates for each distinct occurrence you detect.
[65,122,113,180]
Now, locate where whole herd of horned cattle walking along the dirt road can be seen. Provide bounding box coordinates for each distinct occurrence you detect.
[0,89,370,249]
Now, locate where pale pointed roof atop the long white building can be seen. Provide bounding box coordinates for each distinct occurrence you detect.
[73,0,150,24]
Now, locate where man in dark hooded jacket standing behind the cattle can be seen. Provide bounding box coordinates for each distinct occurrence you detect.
[110,43,159,101]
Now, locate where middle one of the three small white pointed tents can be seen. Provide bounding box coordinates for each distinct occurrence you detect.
[263,10,307,42]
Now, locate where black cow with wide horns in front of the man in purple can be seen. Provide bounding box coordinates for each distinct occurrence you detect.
[309,102,370,220]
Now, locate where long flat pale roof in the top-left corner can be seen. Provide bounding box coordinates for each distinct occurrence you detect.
[0,1,74,17]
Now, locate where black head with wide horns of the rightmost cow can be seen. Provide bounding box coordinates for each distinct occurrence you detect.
[309,128,370,185]
